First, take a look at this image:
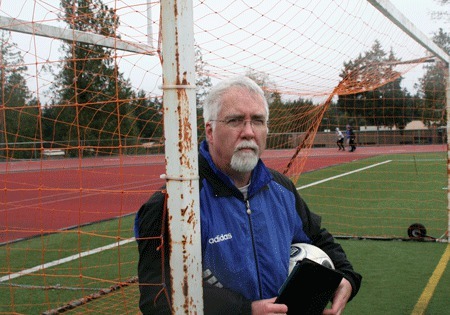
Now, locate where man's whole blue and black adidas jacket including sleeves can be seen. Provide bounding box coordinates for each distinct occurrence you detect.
[135,142,361,314]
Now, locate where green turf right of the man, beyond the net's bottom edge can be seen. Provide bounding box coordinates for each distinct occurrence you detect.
[297,153,447,238]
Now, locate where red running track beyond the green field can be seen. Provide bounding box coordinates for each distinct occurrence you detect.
[0,145,447,244]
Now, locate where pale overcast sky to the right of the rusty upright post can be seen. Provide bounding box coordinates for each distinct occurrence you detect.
[188,0,448,100]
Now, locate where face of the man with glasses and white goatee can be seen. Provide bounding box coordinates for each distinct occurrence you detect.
[206,88,267,174]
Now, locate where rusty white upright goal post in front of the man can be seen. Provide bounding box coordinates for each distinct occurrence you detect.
[161,0,203,315]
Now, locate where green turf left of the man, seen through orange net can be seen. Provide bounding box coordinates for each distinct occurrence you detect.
[0,216,137,314]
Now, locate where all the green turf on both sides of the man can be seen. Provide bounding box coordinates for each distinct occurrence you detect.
[0,153,450,314]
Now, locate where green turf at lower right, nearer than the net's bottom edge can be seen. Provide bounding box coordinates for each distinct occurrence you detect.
[340,240,450,315]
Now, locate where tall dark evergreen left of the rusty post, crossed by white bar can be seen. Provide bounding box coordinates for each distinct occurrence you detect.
[44,0,138,155]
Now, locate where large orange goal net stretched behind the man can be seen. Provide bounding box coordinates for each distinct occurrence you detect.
[0,0,450,314]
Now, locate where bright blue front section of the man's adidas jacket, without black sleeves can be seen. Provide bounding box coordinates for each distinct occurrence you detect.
[200,143,311,300]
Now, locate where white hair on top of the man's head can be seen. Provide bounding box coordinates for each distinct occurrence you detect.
[203,76,269,124]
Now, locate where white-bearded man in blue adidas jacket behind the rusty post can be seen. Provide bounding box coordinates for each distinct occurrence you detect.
[135,77,361,315]
